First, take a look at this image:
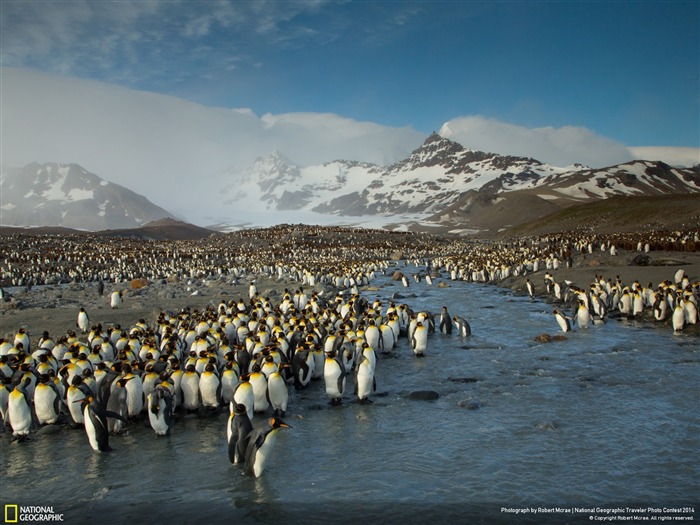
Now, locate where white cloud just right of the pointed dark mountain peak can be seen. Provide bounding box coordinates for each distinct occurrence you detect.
[440,116,634,168]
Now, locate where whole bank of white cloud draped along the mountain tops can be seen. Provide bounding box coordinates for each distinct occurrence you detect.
[0,68,697,224]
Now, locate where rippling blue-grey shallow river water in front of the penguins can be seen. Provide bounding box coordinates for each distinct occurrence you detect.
[0,270,700,523]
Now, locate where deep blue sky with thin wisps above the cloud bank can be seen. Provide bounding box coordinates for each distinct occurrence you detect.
[1,0,700,147]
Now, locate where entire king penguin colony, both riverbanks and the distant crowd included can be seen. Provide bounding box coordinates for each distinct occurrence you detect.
[0,225,699,476]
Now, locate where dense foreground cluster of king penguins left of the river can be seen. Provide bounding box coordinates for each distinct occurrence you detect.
[0,265,470,477]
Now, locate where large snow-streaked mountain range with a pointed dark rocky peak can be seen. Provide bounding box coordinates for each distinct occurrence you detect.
[223,133,700,227]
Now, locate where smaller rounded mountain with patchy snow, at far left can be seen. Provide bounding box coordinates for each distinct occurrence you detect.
[0,163,174,231]
